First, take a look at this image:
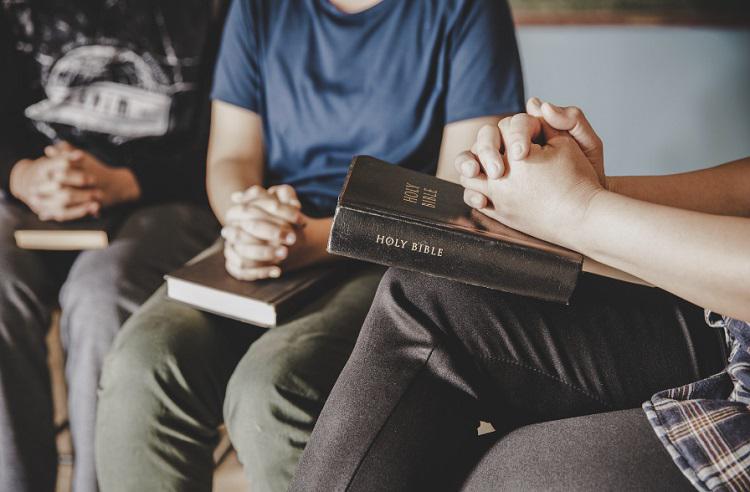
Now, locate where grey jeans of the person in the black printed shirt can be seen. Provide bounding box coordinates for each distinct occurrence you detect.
[0,197,217,492]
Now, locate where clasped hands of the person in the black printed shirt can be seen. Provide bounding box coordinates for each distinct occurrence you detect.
[10,142,141,222]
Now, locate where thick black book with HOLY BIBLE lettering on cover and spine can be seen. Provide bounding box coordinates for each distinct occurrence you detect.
[328,156,641,303]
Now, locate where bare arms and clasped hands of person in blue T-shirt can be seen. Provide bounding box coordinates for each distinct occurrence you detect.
[207,97,508,280]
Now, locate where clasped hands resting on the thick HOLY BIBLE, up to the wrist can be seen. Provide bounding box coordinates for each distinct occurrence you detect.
[455,98,606,248]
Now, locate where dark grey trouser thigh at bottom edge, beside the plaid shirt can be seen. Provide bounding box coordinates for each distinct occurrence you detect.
[463,408,693,491]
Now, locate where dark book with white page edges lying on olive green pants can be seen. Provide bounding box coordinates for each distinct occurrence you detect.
[165,251,341,328]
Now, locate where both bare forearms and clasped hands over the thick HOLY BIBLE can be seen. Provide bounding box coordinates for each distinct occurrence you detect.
[455,99,750,320]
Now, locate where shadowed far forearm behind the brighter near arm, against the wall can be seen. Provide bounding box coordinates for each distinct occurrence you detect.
[607,157,750,217]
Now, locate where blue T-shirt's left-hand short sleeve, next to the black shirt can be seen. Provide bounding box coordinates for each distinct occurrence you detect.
[211,0,262,113]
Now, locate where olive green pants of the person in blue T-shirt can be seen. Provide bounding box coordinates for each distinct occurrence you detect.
[96,266,384,492]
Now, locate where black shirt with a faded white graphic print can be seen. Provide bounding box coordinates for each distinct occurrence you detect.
[0,0,222,201]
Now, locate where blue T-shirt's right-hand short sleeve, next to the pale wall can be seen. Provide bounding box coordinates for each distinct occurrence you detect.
[445,0,524,123]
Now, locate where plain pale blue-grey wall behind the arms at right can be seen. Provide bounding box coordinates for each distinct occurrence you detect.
[518,26,750,175]
